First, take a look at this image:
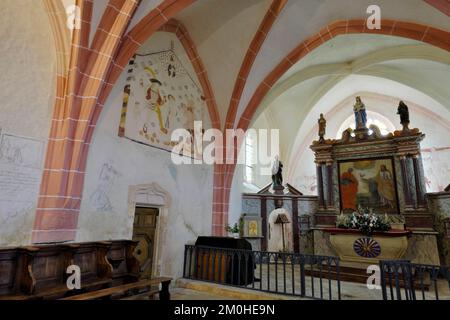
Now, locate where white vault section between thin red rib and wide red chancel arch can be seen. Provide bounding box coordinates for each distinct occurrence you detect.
[235,0,450,124]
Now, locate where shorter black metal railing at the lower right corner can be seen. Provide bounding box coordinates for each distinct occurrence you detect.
[380,260,450,300]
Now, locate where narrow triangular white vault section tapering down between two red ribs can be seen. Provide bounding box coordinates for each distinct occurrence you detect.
[176,0,271,123]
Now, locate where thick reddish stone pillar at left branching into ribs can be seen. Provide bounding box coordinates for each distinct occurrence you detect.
[32,0,199,243]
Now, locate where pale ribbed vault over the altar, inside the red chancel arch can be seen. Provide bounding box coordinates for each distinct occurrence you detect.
[248,31,450,172]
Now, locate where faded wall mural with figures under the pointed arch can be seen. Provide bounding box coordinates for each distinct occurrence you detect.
[119,50,209,159]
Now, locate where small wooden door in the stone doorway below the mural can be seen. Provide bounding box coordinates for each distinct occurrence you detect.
[133,207,159,278]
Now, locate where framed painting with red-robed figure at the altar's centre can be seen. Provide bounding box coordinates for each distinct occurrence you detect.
[339,158,398,214]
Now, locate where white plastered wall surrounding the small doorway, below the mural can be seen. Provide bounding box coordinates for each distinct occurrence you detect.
[76,32,213,277]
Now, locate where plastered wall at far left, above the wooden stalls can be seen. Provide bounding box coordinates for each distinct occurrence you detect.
[0,0,56,246]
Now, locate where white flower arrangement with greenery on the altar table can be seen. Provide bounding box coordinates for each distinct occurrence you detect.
[337,207,391,236]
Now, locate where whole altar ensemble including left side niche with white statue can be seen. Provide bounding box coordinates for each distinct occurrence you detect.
[242,99,450,272]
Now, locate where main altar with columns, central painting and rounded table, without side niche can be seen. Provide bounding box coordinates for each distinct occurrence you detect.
[311,98,440,268]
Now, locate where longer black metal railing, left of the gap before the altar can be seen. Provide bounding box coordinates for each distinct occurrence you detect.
[183,245,341,300]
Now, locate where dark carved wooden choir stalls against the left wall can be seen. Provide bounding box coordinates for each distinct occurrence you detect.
[0,240,139,300]
